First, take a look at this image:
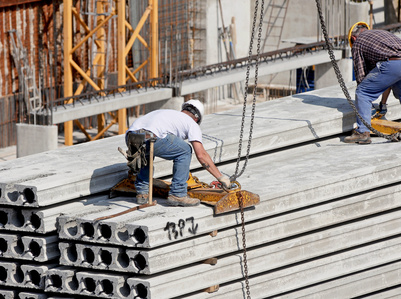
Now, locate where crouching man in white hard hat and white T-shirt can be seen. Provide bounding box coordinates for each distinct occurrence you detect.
[126,99,231,206]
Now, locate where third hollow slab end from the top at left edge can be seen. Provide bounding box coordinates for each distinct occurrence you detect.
[0,233,60,262]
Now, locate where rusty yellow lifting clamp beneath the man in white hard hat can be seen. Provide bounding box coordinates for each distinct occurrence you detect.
[110,171,260,215]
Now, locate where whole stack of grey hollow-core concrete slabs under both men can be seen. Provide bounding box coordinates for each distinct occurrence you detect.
[0,84,401,298]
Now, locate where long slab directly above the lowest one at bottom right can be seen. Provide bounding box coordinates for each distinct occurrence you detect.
[185,238,401,299]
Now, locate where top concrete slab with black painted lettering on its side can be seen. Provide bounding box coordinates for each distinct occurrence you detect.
[59,138,401,248]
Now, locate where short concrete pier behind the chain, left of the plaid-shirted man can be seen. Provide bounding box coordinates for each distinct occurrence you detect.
[315,58,353,89]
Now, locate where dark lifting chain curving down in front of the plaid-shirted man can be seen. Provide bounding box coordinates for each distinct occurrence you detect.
[316,0,401,141]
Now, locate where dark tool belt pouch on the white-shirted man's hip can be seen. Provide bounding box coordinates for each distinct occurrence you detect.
[127,129,156,174]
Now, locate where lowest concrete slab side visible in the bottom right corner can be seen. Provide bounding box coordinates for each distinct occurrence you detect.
[282,262,401,299]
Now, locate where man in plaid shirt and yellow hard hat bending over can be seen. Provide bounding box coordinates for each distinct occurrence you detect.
[344,22,401,144]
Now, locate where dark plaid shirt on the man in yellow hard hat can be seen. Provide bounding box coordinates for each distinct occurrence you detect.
[352,30,401,84]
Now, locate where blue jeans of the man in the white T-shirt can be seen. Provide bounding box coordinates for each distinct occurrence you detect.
[135,134,192,197]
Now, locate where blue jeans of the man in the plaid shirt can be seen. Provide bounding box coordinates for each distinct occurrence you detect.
[355,60,401,133]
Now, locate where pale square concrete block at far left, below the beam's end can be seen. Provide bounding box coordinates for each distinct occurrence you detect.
[17,124,58,158]
